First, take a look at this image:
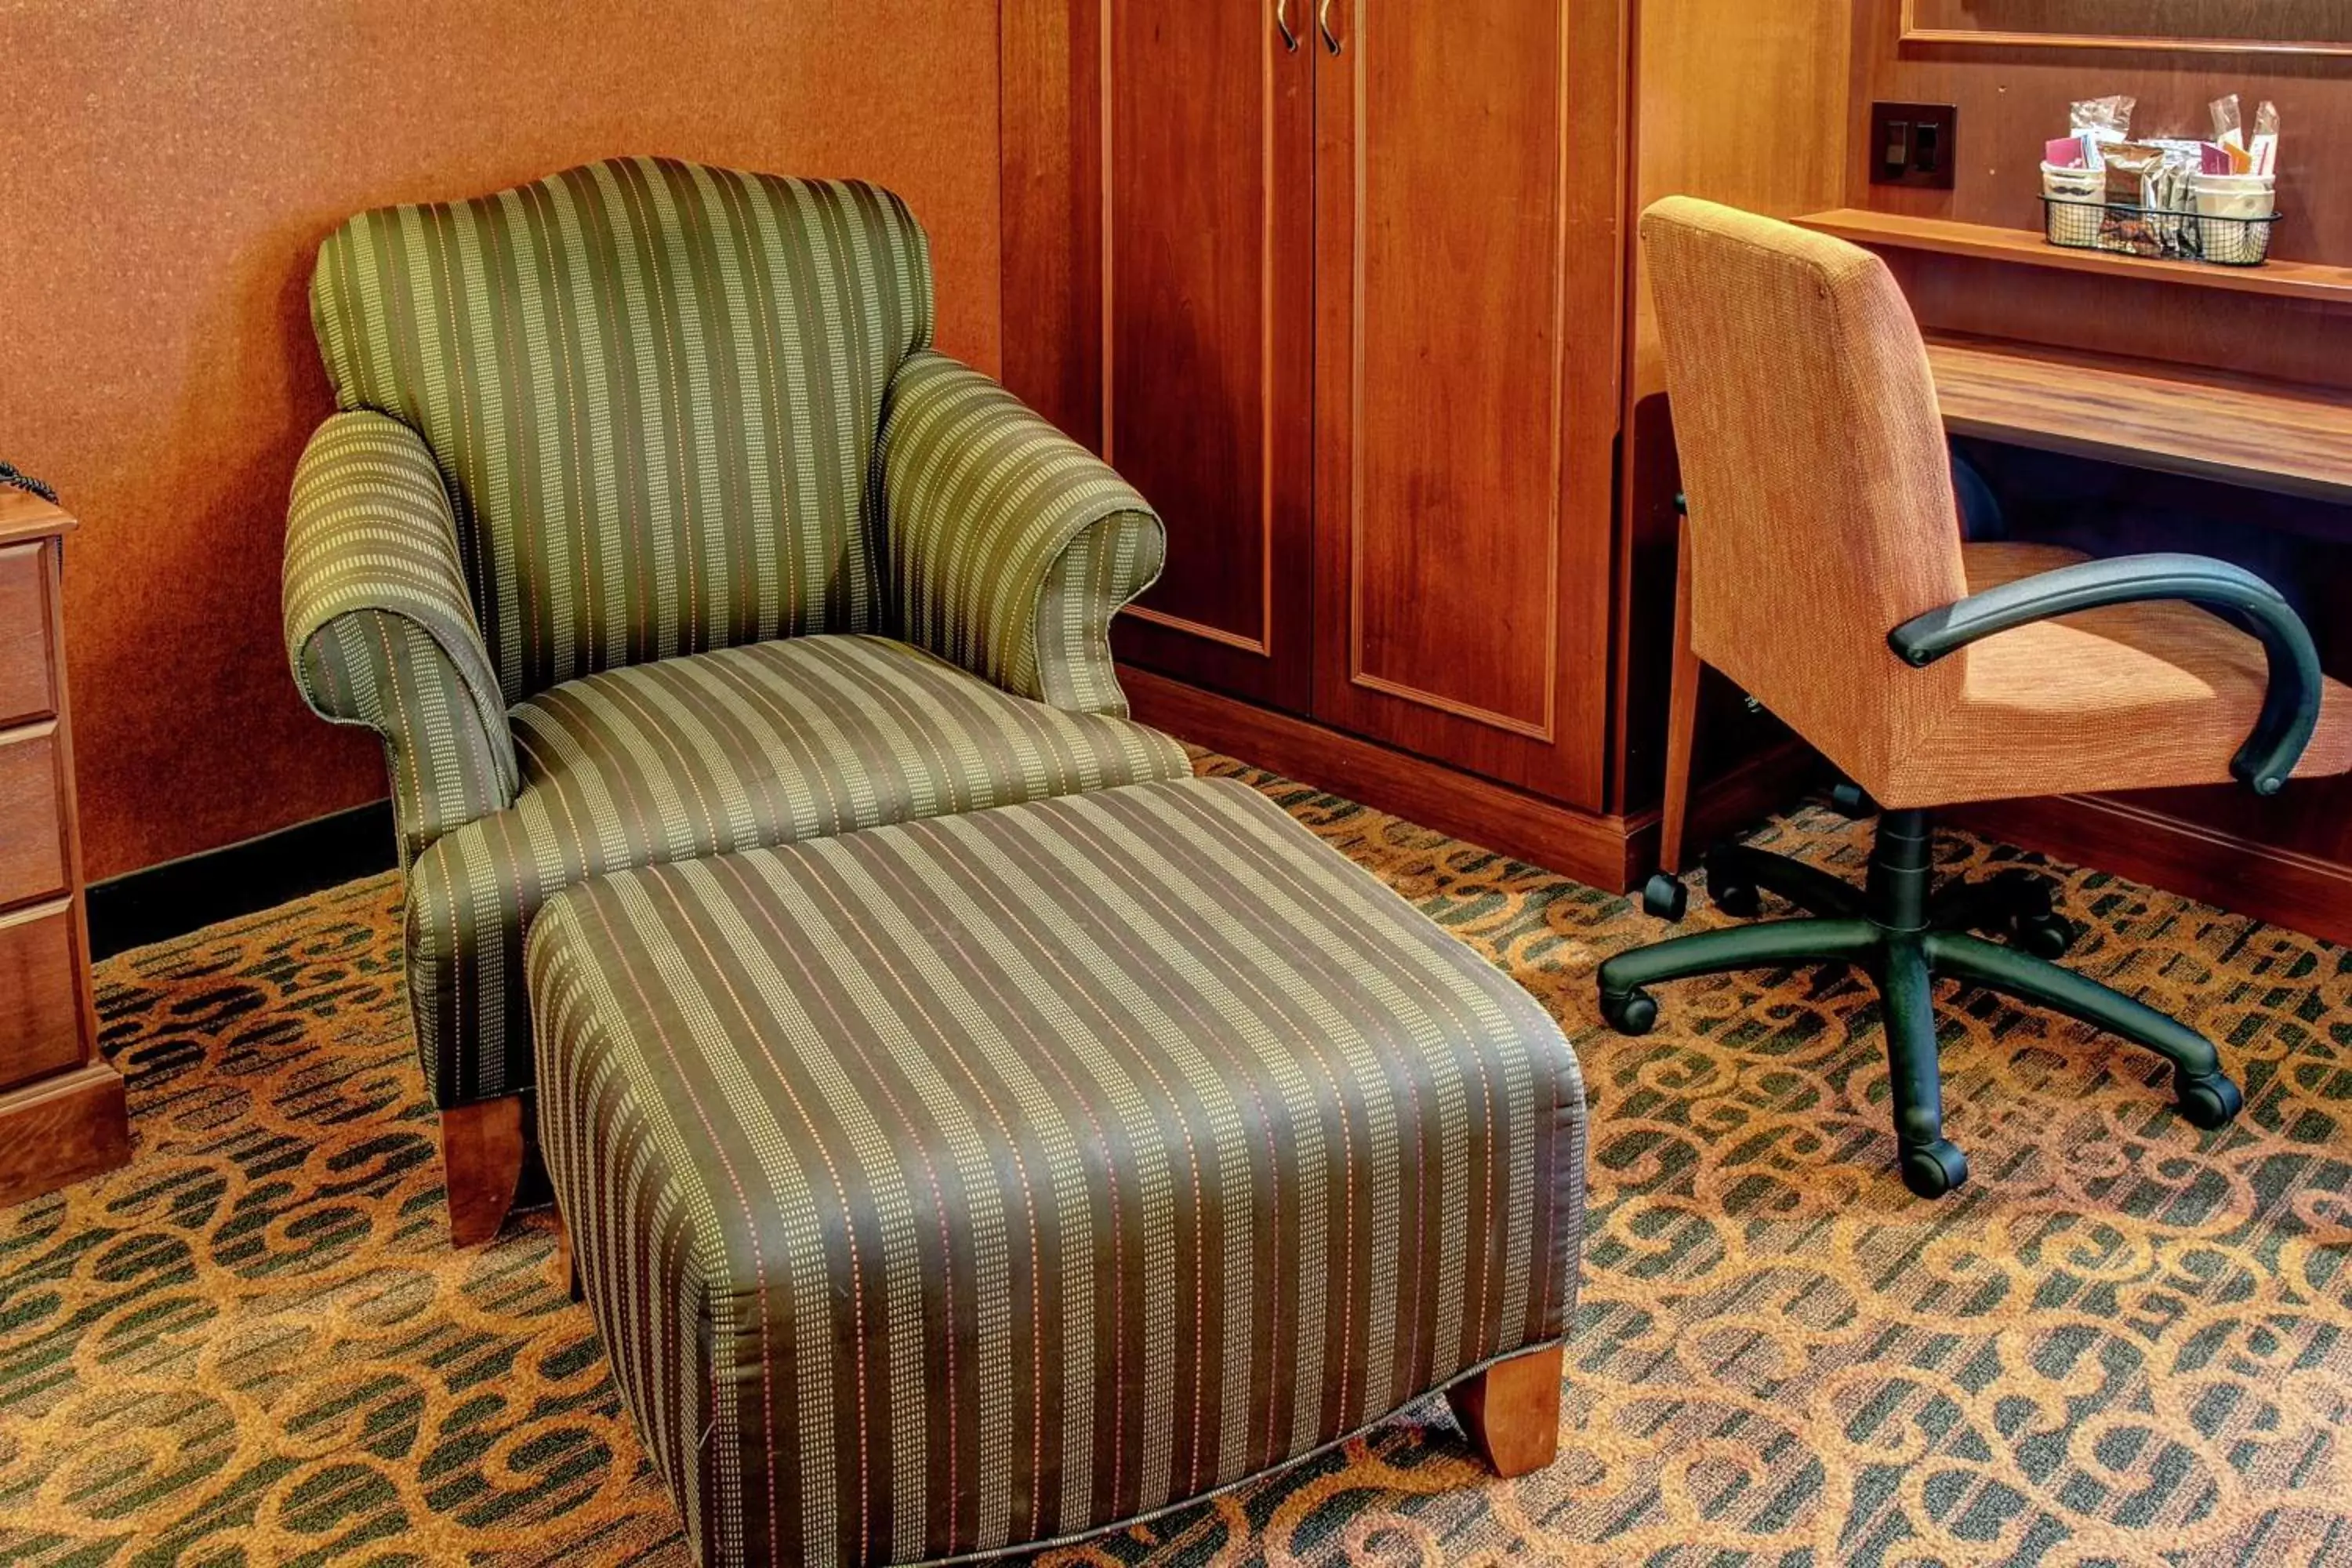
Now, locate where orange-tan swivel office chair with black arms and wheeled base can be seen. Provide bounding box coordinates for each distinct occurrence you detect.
[1599,198,2352,1196]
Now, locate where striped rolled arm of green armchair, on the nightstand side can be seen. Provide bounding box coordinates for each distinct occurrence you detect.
[285,409,520,865]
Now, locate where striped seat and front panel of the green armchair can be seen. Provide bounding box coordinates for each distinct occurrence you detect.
[407,637,1192,1105]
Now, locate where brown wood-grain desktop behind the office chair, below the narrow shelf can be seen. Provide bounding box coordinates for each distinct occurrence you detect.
[1926,336,2352,506]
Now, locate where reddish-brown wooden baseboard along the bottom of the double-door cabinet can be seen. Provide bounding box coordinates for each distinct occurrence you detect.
[1120,666,1813,893]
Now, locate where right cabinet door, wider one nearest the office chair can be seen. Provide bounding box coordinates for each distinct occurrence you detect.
[1312,0,1623,808]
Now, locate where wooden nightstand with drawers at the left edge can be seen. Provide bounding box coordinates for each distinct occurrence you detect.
[0,487,132,1206]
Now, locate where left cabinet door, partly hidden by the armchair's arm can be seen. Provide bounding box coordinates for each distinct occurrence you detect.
[1105,0,1315,710]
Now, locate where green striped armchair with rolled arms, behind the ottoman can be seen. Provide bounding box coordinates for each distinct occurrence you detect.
[285,158,1190,1243]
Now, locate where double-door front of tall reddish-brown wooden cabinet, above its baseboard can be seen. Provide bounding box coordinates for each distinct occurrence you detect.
[1004,0,1623,811]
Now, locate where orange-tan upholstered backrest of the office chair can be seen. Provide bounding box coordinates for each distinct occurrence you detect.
[1642,198,1969,799]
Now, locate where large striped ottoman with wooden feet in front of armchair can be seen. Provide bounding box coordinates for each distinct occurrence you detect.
[527,781,1585,1563]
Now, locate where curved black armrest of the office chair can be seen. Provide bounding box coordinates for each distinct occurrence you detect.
[1886,555,2321,794]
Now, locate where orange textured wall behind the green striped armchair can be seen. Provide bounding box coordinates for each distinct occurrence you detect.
[0,0,1000,877]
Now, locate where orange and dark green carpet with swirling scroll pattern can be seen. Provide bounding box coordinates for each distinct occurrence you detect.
[0,760,2352,1568]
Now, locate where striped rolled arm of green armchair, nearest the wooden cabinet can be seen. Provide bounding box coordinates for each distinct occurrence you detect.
[880,350,1167,717]
